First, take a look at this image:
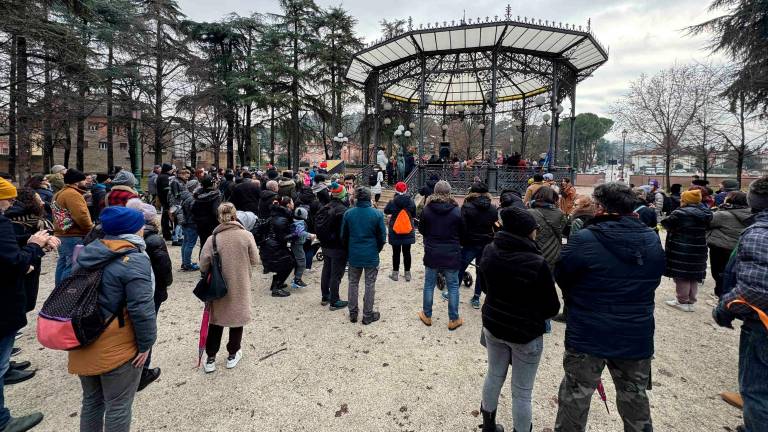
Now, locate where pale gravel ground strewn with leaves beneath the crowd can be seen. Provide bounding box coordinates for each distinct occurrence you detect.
[6,228,741,432]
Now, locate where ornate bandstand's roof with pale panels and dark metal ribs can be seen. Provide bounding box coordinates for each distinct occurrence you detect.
[346,17,608,106]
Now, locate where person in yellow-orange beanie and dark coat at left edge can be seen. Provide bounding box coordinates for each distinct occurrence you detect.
[0,178,59,431]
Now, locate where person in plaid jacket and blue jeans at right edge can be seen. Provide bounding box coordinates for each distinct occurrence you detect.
[712,176,768,432]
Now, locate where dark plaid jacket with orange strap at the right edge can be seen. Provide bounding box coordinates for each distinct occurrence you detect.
[720,210,768,325]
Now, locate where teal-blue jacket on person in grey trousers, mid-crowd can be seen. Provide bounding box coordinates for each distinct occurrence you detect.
[341,200,387,267]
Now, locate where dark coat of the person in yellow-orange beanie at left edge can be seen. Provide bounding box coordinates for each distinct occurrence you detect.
[0,214,45,337]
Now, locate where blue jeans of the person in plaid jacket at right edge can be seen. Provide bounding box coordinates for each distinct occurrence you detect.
[739,321,768,432]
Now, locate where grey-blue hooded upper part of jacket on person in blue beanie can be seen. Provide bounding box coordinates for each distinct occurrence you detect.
[77,240,157,352]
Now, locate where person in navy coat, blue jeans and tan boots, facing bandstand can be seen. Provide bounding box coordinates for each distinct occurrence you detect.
[418,180,464,330]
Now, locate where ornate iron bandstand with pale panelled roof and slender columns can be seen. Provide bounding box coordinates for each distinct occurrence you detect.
[346,6,608,192]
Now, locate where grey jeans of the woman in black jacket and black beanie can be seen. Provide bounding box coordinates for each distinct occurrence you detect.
[483,328,544,431]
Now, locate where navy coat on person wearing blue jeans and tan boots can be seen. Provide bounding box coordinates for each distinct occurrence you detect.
[419,194,464,270]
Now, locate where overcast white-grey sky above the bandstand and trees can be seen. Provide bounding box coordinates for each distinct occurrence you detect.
[177,0,723,115]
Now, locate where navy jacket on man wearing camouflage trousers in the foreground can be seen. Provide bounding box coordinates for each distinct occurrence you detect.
[555,216,665,360]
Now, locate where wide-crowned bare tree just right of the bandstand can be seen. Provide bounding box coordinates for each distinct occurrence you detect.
[611,64,711,187]
